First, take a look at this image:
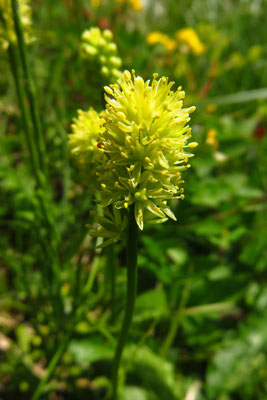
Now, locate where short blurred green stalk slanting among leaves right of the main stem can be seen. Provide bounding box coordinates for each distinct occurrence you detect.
[160,266,192,357]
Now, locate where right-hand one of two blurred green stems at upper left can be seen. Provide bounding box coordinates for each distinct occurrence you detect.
[11,0,48,179]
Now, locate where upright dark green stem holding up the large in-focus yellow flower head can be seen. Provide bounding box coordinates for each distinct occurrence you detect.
[112,204,138,400]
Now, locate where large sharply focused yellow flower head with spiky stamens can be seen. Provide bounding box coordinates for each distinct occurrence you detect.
[98,71,197,229]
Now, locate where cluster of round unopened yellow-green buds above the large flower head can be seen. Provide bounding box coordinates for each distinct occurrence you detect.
[81,27,122,82]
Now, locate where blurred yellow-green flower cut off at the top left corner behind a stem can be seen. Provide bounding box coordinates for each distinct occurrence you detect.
[0,0,34,49]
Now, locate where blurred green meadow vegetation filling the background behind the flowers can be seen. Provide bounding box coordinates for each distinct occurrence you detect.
[0,0,267,400]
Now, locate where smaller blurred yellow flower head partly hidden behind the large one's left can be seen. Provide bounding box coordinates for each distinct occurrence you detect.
[69,108,104,187]
